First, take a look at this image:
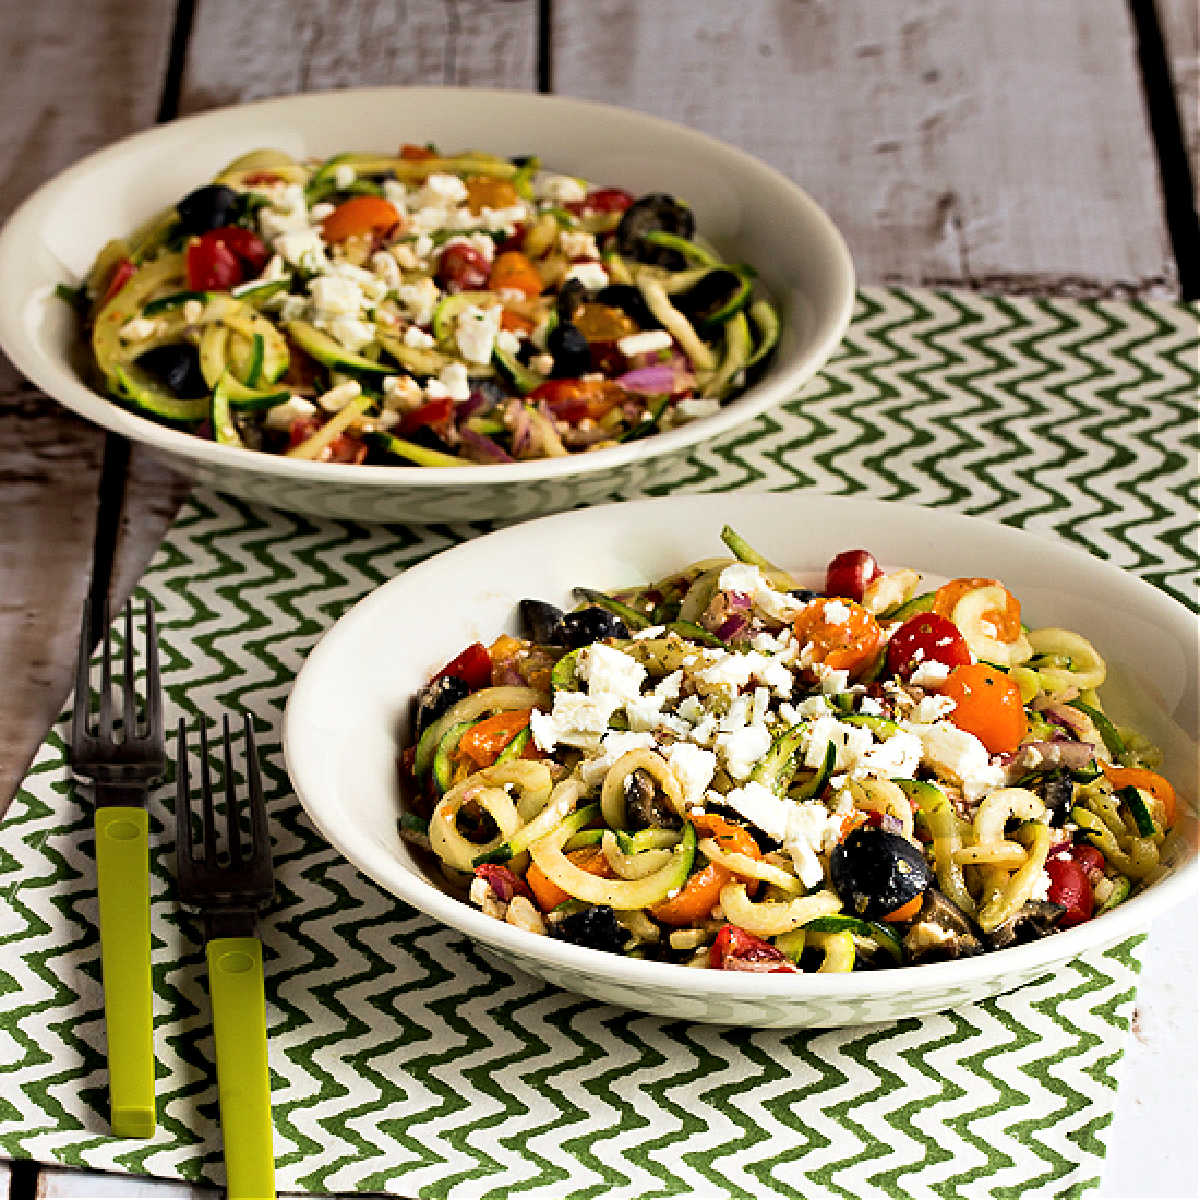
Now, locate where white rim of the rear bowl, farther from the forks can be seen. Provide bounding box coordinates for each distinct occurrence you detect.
[0,86,854,488]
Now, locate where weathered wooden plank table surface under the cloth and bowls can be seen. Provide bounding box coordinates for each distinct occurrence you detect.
[0,0,1200,1198]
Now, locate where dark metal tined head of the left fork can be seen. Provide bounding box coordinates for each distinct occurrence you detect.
[71,599,166,780]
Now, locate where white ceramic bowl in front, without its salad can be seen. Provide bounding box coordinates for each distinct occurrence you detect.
[284,493,1198,1027]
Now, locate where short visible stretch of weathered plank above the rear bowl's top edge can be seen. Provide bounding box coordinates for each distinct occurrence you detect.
[181,0,536,113]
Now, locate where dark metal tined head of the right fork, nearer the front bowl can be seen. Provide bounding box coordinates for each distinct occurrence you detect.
[175,713,274,908]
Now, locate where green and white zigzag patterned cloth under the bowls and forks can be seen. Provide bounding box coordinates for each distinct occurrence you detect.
[0,289,1200,1200]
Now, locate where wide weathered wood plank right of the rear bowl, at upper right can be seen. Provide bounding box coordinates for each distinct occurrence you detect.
[552,0,1187,294]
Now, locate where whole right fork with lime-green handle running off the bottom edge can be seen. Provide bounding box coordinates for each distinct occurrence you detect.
[175,713,275,1200]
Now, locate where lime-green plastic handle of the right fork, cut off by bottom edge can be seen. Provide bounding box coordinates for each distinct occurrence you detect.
[206,937,275,1200]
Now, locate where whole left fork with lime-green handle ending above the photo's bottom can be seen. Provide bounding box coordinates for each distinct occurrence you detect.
[71,600,166,1138]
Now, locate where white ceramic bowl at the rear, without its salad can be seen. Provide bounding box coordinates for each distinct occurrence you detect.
[0,88,854,521]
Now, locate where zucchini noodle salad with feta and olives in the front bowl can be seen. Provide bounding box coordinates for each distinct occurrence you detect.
[401,527,1176,972]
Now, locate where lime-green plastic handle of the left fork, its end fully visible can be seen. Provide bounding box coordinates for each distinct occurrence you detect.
[96,806,155,1138]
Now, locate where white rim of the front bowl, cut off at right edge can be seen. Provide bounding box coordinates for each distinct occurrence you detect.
[282,490,1200,1003]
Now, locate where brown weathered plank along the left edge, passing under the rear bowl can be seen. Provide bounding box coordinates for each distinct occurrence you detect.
[0,0,173,811]
